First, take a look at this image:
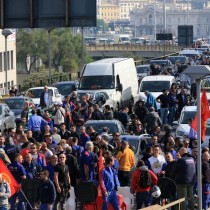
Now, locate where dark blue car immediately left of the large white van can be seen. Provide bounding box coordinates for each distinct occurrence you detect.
[53,81,79,100]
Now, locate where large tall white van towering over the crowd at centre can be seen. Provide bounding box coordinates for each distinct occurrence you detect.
[77,58,138,111]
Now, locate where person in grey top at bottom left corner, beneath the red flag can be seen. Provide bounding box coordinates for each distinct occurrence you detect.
[0,174,11,210]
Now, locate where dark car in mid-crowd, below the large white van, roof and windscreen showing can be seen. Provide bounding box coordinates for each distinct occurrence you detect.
[85,120,126,135]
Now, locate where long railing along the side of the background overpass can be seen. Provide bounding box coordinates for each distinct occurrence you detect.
[86,44,180,52]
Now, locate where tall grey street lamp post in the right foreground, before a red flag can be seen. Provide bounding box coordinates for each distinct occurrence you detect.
[183,65,210,209]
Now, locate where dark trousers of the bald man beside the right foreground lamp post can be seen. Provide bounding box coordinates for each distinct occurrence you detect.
[176,184,195,210]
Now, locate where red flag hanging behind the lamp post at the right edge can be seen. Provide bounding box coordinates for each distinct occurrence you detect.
[192,89,209,142]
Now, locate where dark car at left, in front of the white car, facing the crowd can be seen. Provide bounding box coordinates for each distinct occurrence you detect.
[3,96,34,120]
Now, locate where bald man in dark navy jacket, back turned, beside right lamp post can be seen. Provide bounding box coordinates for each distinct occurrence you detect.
[174,147,196,210]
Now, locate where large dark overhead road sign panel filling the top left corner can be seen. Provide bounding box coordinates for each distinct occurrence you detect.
[0,0,96,28]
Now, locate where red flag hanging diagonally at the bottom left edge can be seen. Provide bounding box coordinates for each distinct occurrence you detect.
[0,159,20,196]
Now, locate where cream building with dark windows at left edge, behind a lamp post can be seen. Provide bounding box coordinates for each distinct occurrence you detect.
[0,30,17,95]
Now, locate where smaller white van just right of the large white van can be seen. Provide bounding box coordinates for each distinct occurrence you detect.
[139,75,176,110]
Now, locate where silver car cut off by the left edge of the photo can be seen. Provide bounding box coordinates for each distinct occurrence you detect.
[0,103,15,131]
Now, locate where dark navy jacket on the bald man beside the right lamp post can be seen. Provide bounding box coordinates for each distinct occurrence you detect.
[174,153,196,185]
